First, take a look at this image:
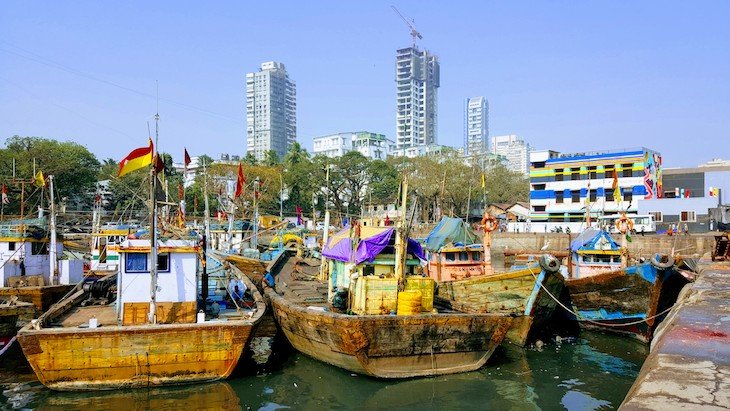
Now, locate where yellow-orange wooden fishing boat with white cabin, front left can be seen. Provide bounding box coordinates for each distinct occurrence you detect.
[18,240,265,391]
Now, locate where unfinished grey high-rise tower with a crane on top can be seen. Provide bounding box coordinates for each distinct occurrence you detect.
[395,46,440,149]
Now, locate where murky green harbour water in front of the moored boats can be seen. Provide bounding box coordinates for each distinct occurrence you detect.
[0,332,648,410]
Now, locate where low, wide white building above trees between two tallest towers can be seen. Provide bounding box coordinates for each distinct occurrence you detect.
[312,131,395,160]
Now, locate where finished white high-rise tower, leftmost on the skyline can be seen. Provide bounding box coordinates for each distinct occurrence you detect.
[246,61,297,160]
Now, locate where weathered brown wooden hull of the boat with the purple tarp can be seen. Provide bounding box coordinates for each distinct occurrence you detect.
[267,291,512,378]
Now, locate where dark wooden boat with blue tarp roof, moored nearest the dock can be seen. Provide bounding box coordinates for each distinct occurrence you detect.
[566,228,693,342]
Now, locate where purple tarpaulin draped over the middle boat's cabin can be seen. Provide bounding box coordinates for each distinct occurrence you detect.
[322,227,426,264]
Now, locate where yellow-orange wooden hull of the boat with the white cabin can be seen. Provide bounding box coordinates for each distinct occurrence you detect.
[18,322,253,391]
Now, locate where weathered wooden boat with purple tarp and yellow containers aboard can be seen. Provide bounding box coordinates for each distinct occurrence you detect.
[265,179,512,378]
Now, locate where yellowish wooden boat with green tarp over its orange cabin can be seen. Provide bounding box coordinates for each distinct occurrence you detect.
[425,217,564,346]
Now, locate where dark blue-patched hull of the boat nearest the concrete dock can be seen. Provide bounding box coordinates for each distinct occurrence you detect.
[566,263,687,342]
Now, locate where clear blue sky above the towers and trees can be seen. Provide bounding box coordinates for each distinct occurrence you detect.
[0,1,730,167]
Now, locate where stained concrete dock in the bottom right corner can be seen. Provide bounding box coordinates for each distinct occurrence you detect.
[621,261,730,411]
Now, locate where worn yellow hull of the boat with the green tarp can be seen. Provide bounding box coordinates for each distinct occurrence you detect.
[437,265,565,346]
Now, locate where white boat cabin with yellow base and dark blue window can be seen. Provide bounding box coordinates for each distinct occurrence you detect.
[117,240,198,325]
